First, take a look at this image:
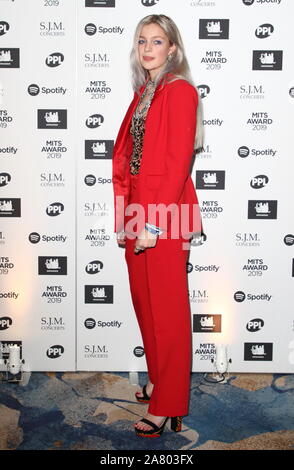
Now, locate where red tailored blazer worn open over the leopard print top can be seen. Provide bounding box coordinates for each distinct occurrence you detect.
[112,75,202,241]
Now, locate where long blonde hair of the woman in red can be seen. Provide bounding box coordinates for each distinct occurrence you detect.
[130,15,203,150]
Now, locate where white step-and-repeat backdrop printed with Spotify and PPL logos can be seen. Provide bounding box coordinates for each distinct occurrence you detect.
[0,0,294,373]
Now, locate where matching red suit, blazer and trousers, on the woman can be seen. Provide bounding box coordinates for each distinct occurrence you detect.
[112,75,202,416]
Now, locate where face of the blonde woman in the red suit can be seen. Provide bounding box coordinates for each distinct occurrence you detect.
[138,23,176,80]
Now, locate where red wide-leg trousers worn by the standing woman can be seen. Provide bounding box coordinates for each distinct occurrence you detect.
[125,173,192,416]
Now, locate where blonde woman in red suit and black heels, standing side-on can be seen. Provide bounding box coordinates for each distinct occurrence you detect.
[112,15,202,437]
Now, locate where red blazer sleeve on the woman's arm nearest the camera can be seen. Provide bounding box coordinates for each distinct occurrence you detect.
[146,80,198,230]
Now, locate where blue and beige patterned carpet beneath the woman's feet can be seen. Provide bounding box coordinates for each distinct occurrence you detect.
[0,372,294,450]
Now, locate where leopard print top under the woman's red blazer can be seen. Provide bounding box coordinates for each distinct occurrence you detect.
[129,80,156,175]
